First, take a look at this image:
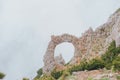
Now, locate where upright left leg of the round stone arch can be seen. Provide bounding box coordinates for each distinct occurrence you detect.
[43,41,56,75]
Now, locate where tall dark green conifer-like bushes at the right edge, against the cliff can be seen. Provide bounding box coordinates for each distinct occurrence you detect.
[101,41,120,70]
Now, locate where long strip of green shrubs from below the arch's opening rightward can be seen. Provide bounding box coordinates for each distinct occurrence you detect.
[48,59,104,80]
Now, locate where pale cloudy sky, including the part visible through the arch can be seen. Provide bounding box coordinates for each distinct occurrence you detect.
[0,0,120,80]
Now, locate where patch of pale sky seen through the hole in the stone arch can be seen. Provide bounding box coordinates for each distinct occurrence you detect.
[54,42,74,64]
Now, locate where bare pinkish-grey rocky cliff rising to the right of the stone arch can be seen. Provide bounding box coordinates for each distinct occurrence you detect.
[79,8,120,59]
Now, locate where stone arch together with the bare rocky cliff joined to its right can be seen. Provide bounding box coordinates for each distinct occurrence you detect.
[43,9,120,73]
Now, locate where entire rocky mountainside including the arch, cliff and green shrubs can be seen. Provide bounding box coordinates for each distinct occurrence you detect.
[34,8,120,80]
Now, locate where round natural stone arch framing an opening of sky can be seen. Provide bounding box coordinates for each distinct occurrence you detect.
[43,34,81,74]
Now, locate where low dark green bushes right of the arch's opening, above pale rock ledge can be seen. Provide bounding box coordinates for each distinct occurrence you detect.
[69,58,104,74]
